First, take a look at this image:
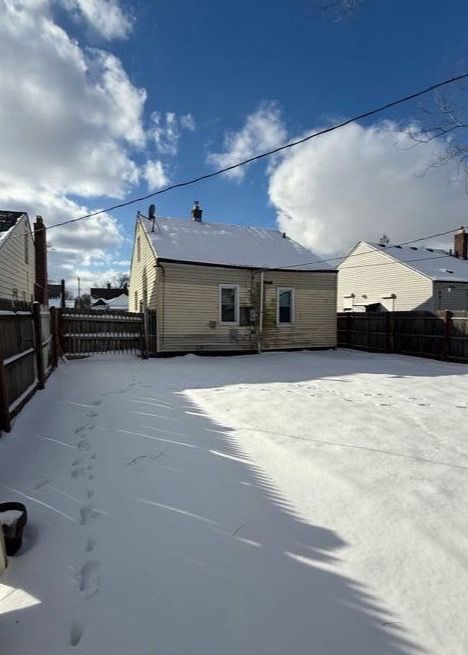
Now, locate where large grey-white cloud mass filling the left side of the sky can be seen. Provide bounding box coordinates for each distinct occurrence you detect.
[0,0,146,286]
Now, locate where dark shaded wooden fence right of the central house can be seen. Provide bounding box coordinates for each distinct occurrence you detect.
[338,311,468,362]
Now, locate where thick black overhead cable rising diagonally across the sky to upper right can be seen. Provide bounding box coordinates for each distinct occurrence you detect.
[10,72,468,236]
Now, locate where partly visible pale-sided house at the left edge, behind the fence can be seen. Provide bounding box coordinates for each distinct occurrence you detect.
[0,211,35,301]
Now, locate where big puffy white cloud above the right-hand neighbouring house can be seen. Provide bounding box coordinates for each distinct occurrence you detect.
[269,122,466,254]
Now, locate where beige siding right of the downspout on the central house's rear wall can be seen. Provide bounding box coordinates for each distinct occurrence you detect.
[262,271,337,350]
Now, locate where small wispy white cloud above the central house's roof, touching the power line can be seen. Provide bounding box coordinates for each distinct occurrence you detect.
[208,103,287,181]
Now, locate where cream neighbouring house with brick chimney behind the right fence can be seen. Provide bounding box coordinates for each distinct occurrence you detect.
[337,230,468,312]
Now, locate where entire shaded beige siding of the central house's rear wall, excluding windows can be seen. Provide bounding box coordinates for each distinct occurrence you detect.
[158,262,336,352]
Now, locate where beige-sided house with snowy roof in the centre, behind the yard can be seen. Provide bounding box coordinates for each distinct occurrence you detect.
[130,203,337,352]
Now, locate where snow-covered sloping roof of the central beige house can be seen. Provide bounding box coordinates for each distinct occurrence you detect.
[140,218,333,271]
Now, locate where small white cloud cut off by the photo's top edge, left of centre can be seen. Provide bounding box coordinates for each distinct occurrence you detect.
[62,0,133,40]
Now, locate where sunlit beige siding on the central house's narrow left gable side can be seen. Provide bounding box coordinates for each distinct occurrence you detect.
[128,219,156,312]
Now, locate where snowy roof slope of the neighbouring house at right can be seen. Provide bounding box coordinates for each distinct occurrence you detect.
[367,243,468,282]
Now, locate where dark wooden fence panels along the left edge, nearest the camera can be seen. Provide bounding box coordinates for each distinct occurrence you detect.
[0,300,56,431]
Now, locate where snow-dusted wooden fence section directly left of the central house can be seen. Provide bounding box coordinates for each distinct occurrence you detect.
[59,309,149,356]
